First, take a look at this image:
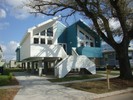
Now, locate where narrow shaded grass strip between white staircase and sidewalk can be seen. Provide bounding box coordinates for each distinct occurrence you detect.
[48,74,102,82]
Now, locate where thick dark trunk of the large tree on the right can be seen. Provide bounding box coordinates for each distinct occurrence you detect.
[116,46,133,79]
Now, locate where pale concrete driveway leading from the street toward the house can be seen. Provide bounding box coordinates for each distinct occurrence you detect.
[14,72,96,100]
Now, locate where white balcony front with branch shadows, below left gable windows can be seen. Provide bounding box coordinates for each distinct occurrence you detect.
[31,44,67,57]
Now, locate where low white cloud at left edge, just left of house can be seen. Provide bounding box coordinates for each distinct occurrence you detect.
[0,41,19,61]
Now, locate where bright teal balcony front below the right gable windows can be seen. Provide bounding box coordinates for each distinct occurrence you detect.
[76,47,102,58]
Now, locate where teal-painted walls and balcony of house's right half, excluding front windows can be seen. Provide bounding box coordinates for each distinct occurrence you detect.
[57,21,102,58]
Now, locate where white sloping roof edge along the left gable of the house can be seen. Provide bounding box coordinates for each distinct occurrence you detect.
[20,16,61,45]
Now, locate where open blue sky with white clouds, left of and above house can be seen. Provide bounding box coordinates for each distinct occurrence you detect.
[0,0,90,61]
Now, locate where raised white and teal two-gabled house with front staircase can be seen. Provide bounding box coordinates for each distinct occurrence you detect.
[16,17,102,78]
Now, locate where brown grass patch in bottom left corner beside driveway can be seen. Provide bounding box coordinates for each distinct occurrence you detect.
[0,88,19,100]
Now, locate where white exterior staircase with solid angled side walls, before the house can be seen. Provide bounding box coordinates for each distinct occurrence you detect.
[55,49,96,78]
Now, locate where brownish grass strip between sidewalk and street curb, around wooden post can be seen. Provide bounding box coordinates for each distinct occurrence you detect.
[64,78,133,94]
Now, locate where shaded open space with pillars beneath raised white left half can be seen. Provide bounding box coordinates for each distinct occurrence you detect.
[22,57,61,76]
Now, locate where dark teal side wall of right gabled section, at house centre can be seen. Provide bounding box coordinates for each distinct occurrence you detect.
[66,24,77,55]
